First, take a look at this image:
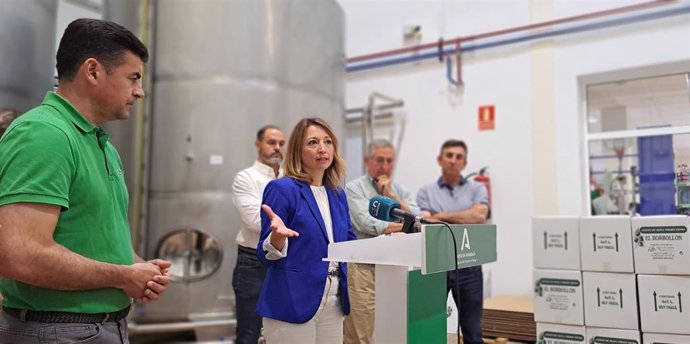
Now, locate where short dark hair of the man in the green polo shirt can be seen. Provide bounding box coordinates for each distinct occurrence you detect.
[56,18,149,81]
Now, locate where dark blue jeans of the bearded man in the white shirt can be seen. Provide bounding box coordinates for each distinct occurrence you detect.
[232,251,266,344]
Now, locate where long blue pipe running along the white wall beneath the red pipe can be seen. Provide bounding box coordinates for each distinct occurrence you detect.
[346,6,690,72]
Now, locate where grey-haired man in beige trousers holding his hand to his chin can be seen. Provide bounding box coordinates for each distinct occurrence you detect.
[344,139,420,344]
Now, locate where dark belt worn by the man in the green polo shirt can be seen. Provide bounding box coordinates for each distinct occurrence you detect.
[2,306,130,324]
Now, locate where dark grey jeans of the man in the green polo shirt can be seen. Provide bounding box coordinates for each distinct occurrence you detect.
[0,312,129,344]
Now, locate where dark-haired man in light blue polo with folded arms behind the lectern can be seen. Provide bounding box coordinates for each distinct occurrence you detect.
[417,140,489,344]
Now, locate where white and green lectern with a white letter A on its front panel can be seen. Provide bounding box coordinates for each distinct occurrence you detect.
[325,225,496,344]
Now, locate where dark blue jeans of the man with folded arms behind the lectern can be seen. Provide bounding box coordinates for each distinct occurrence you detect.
[446,265,484,344]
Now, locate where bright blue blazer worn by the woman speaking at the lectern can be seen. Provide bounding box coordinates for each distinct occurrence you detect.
[256,177,356,324]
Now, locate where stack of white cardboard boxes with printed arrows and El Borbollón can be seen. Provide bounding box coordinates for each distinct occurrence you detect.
[533,216,690,344]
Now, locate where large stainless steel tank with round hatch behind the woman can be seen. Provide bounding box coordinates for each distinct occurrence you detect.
[130,0,345,338]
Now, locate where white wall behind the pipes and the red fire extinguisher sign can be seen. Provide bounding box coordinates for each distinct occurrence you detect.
[339,0,690,296]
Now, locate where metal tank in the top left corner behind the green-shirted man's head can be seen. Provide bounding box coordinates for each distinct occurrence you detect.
[0,0,57,112]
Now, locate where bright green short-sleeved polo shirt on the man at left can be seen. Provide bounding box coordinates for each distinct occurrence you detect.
[0,92,134,313]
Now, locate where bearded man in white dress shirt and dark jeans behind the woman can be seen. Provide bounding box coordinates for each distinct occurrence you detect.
[232,125,285,344]
